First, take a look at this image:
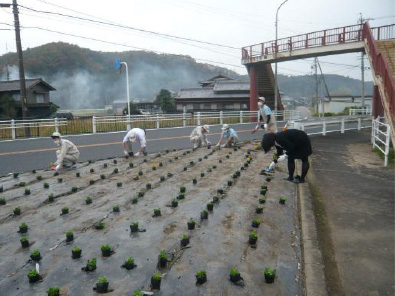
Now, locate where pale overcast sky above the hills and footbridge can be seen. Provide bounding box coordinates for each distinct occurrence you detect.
[0,0,395,80]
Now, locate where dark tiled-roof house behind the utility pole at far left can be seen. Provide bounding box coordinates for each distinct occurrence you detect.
[0,78,56,119]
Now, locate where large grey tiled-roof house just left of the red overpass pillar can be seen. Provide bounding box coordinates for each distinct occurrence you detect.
[174,74,250,112]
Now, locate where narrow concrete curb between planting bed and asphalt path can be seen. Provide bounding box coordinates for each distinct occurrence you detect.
[297,170,328,296]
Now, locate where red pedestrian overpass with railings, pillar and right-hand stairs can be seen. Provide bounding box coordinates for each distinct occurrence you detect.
[242,22,395,141]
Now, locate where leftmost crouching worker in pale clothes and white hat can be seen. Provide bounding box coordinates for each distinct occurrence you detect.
[51,132,80,171]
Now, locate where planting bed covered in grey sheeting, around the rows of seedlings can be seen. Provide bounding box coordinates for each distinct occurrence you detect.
[0,143,303,296]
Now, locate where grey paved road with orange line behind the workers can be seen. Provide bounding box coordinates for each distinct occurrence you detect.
[0,118,372,175]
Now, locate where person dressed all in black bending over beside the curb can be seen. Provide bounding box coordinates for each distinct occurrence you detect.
[261,129,313,183]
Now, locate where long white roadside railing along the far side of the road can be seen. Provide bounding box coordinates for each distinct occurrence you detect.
[0,110,299,139]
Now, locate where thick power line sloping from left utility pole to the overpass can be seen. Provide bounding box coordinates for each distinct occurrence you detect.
[18,5,240,50]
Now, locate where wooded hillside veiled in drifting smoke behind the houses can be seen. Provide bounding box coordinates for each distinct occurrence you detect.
[0,42,372,109]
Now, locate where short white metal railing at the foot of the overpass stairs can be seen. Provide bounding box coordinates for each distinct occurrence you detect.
[372,117,391,166]
